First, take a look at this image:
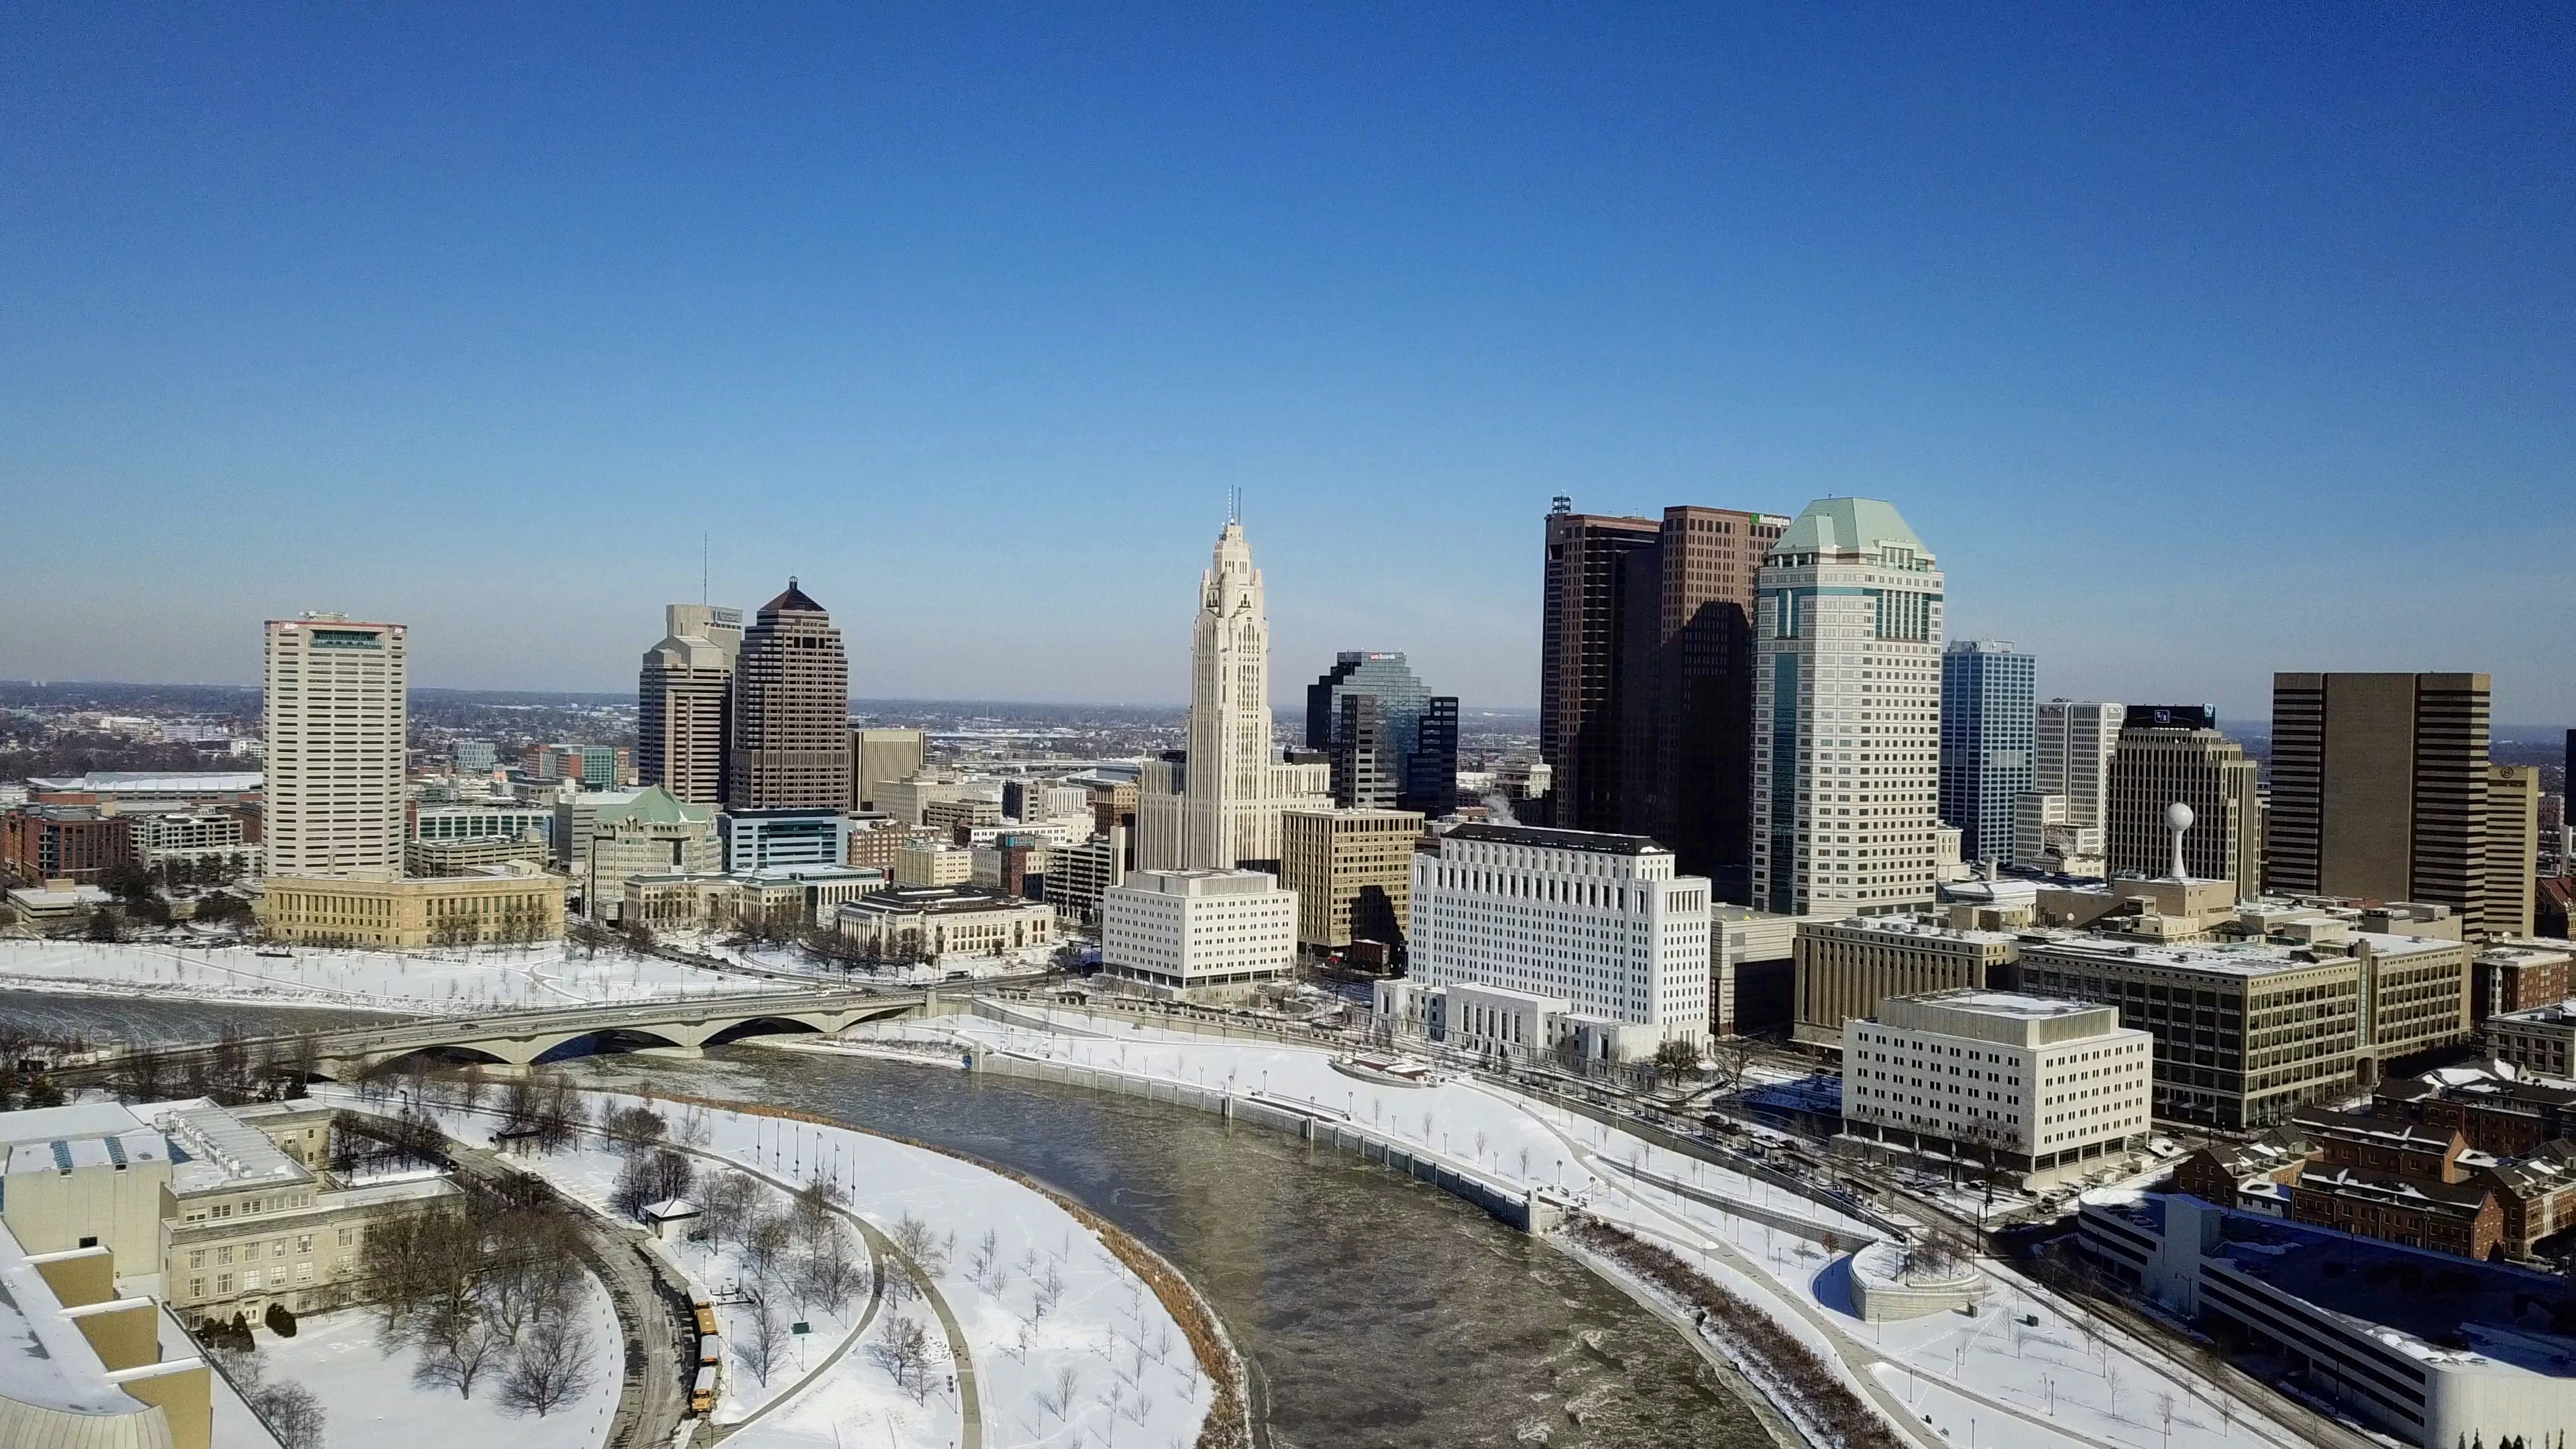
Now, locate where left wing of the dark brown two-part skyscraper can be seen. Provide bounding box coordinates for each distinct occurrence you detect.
[1538,498,1662,830]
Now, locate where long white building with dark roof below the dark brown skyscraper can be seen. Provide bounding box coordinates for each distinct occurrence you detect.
[1409,825,1711,1042]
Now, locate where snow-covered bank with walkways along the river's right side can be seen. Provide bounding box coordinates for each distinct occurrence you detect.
[853,1008,2303,1449]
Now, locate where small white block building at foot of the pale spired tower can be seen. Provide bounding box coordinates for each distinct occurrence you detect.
[1100,869,1296,1000]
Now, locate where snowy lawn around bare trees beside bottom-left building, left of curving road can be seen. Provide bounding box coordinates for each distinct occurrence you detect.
[254,1274,623,1449]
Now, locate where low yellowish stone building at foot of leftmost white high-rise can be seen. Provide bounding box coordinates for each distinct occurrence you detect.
[252,864,564,949]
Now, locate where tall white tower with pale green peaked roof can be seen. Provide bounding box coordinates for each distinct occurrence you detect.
[1749,498,1942,915]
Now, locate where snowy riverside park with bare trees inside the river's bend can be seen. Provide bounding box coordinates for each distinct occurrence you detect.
[325,1088,1218,1449]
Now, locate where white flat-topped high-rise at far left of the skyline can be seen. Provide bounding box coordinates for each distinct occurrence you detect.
[263,614,410,877]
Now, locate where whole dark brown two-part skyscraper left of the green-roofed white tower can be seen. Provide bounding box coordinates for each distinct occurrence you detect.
[1538,494,1788,898]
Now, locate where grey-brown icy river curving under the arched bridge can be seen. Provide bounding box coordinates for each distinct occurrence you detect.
[0,993,1770,1449]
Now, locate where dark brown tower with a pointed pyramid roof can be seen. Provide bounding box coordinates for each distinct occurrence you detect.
[724,578,850,812]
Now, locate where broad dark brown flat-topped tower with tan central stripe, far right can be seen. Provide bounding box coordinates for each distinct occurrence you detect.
[2264,673,2488,930]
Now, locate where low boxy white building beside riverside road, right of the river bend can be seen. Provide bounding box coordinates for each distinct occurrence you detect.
[1842,987,2156,1173]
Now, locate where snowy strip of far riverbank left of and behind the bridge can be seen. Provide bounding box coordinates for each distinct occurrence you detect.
[0,941,781,1016]
